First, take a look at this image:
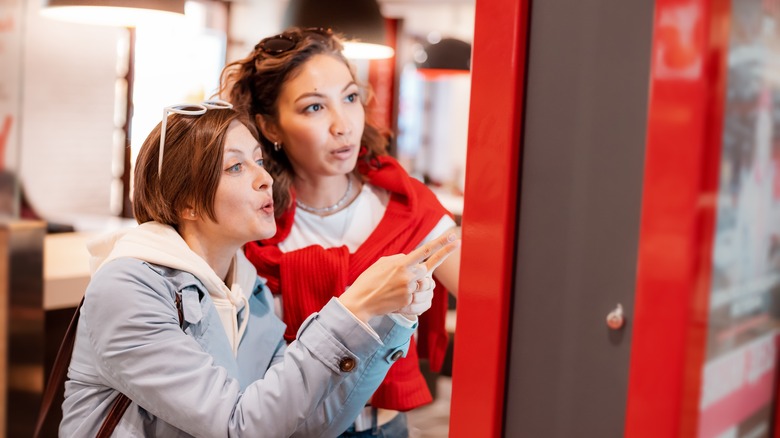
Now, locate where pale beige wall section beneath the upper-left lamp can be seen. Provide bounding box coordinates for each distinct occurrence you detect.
[17,1,122,222]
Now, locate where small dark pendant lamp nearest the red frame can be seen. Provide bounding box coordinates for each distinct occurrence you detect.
[414,38,471,78]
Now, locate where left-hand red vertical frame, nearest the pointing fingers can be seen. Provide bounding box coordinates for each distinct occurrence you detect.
[450,0,528,438]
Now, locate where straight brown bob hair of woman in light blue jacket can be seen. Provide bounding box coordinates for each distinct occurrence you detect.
[133,109,258,229]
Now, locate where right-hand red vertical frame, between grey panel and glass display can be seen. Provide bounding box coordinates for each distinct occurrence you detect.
[626,0,729,437]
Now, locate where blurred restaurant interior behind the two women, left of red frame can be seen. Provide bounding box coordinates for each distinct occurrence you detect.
[0,0,474,436]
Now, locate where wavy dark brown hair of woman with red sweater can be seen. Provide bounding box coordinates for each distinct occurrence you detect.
[218,27,389,217]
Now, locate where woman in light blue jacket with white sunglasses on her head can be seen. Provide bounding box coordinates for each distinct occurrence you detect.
[60,101,459,437]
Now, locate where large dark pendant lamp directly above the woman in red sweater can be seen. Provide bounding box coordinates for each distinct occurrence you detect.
[283,0,395,59]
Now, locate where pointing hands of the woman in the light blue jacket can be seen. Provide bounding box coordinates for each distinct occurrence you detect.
[339,233,460,322]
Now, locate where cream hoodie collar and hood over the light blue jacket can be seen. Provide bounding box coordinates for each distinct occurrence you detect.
[87,222,257,355]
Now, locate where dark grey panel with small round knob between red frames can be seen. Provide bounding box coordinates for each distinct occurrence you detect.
[505,0,653,432]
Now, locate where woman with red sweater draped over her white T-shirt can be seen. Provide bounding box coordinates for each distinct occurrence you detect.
[220,28,460,437]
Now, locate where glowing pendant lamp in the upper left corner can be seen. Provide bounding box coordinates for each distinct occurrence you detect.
[41,0,185,27]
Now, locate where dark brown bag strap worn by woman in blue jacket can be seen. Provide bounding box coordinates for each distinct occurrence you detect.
[33,293,184,438]
